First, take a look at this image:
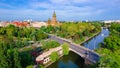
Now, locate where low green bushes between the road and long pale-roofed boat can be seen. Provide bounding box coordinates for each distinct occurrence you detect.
[42,40,60,50]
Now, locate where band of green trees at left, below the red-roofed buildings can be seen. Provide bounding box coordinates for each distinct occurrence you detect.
[0,25,48,41]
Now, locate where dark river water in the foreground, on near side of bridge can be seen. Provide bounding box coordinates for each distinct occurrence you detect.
[48,51,84,68]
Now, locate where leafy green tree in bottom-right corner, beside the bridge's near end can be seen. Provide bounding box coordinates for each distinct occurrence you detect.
[98,49,120,68]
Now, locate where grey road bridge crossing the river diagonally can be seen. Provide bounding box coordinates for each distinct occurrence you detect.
[50,35,100,63]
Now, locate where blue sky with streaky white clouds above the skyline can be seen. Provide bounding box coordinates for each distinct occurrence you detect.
[0,0,120,21]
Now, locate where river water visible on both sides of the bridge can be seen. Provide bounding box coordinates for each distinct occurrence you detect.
[48,29,109,68]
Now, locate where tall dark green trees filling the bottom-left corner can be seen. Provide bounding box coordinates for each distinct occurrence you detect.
[0,42,22,68]
